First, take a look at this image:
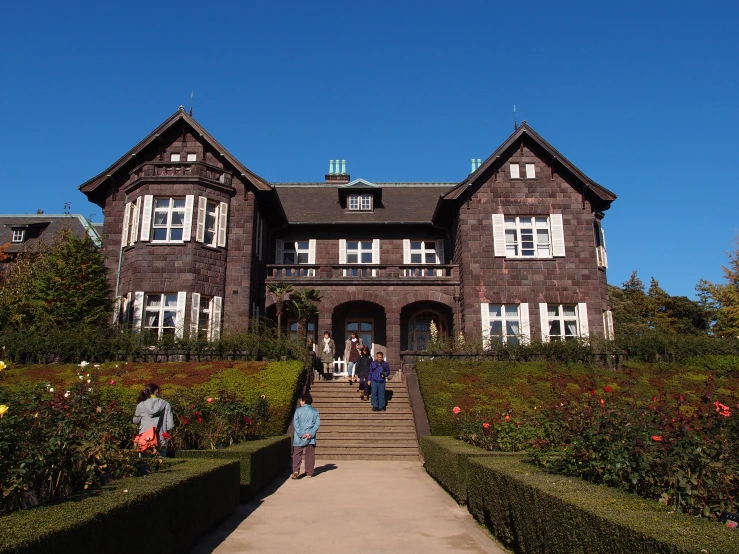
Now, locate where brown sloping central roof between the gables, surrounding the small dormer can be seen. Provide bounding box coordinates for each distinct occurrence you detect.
[273,181,457,224]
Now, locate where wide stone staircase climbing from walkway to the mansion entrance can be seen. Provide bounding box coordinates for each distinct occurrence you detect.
[311,375,420,462]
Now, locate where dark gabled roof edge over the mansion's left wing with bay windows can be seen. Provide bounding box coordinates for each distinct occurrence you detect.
[79,106,272,194]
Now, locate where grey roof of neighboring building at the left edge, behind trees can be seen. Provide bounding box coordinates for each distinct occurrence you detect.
[0,214,102,254]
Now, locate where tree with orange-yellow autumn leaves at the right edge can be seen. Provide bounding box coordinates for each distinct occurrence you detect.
[696,237,739,337]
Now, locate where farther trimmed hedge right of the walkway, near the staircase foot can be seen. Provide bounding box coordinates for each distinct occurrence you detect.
[421,436,523,504]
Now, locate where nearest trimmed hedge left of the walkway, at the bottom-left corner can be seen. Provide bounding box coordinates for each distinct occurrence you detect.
[0,460,239,554]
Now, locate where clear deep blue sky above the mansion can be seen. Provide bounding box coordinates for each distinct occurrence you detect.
[0,0,739,295]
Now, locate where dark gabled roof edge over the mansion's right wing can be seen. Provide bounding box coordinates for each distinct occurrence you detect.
[444,121,617,204]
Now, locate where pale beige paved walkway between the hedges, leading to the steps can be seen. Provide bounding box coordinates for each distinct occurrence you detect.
[193,460,506,554]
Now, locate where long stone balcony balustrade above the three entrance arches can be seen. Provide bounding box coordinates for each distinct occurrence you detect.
[267,264,459,285]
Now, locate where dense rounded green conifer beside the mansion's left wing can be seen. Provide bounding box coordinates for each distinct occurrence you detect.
[31,229,112,329]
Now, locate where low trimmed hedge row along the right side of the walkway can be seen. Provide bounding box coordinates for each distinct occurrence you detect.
[422,437,739,554]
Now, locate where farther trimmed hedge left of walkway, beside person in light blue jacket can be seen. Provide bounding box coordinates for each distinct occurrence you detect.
[177,436,291,502]
